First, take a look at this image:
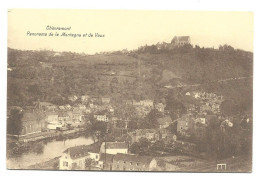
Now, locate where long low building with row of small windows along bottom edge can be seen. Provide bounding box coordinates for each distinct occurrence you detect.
[112,154,157,171]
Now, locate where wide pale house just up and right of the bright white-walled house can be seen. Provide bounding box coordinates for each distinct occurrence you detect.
[129,129,157,143]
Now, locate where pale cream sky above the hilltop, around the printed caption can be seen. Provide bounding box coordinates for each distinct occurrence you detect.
[8,9,254,54]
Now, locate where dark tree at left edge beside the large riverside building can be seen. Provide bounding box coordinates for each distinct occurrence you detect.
[7,107,23,135]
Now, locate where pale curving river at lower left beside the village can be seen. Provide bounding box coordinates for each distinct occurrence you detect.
[6,136,93,169]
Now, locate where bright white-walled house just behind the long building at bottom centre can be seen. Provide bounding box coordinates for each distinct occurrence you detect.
[100,142,128,155]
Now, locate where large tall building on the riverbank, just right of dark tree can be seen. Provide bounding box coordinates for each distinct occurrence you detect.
[20,112,47,135]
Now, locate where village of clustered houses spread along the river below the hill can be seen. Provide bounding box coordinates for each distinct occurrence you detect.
[7,88,250,171]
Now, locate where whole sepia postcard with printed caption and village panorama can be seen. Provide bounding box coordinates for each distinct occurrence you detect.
[6,9,254,173]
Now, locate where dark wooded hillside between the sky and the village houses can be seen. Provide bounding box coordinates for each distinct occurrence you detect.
[8,46,253,113]
